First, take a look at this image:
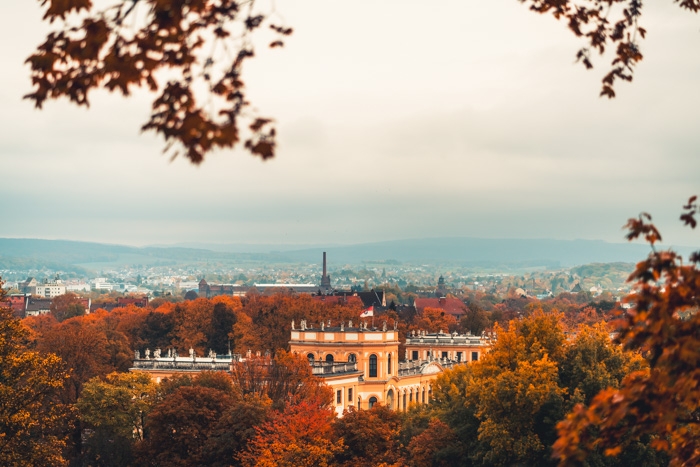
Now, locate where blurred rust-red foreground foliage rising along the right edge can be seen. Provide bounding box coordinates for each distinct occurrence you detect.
[554,196,700,466]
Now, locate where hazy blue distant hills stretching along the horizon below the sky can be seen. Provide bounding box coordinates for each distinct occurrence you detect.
[0,238,689,270]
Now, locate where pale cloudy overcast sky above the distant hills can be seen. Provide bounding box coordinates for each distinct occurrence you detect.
[0,0,700,249]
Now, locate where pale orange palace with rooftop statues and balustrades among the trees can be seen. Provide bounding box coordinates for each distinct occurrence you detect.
[132,320,490,415]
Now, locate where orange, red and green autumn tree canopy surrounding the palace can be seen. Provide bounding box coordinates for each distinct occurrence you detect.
[0,198,700,466]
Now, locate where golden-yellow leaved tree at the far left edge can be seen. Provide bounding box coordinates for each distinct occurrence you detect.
[0,281,68,467]
